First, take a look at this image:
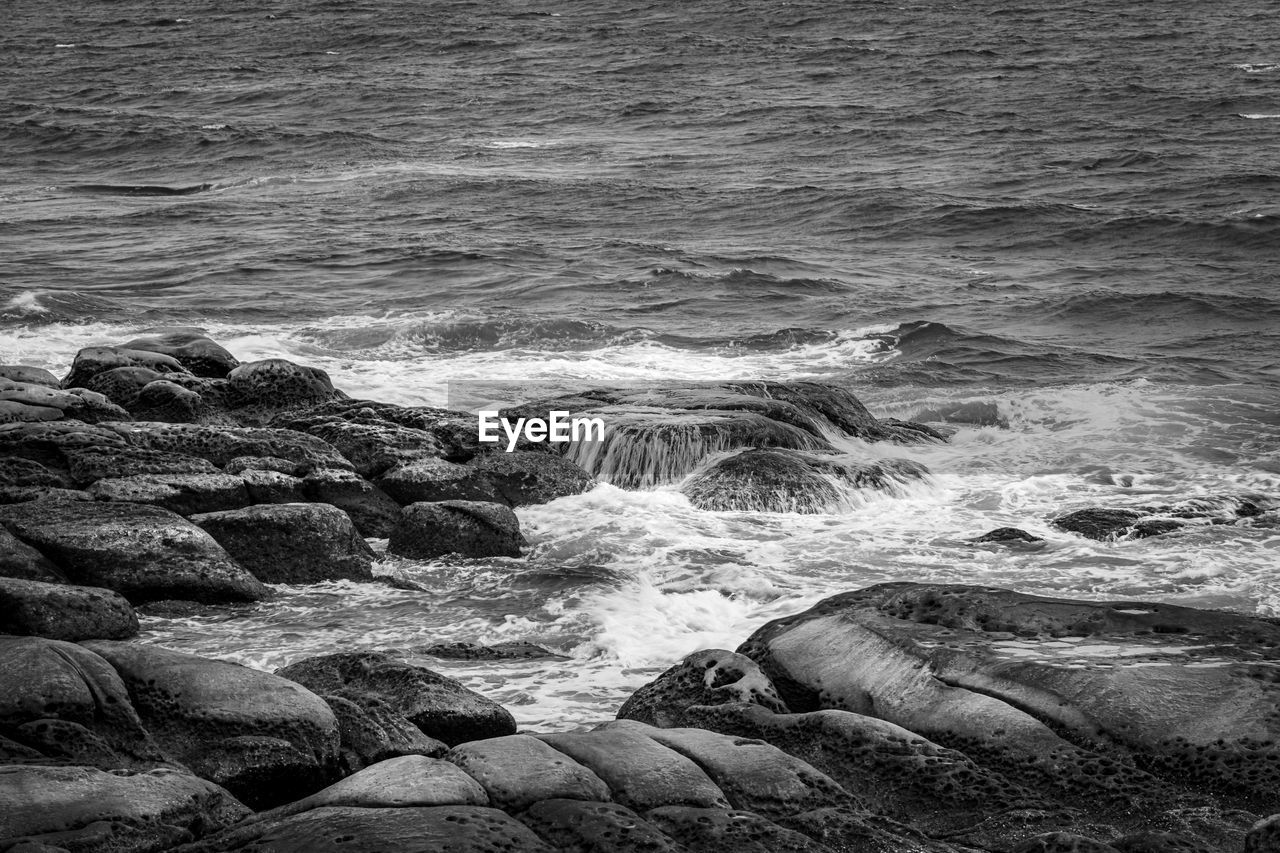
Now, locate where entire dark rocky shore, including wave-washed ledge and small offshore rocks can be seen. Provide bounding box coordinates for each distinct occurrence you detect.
[0,329,1280,853]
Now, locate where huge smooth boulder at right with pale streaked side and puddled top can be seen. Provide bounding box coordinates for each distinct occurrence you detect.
[739,583,1280,811]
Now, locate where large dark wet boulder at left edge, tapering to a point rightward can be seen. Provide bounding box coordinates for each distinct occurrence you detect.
[0,501,268,602]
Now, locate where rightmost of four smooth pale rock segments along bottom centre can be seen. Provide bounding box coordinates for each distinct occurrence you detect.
[600,720,854,817]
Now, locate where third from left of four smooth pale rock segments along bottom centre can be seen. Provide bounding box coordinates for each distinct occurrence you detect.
[538,729,730,812]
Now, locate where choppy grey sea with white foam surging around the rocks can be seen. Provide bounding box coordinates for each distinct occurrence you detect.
[0,0,1280,730]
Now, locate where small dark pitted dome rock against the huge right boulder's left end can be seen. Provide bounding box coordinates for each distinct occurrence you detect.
[618,648,788,729]
